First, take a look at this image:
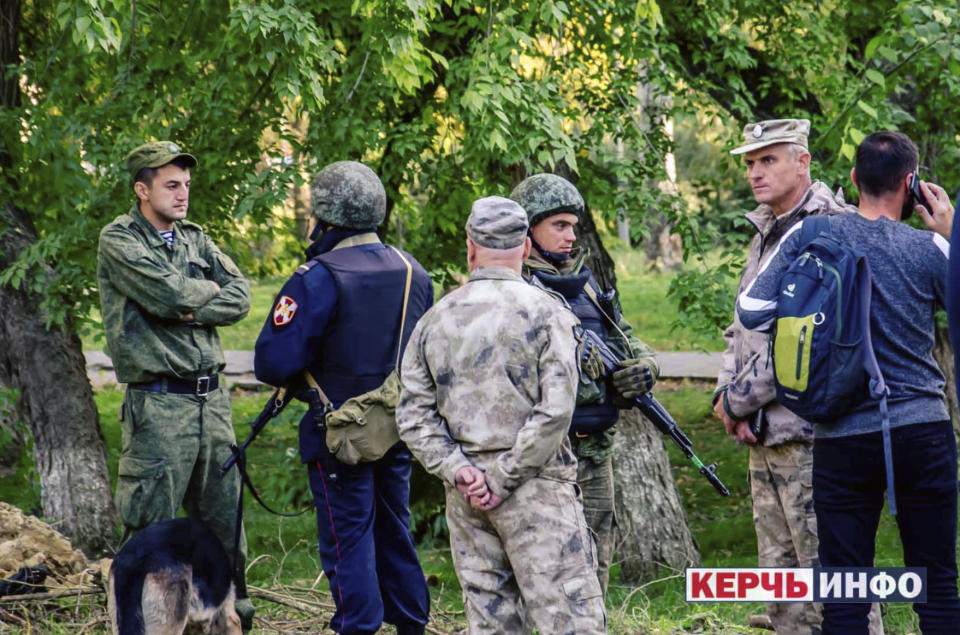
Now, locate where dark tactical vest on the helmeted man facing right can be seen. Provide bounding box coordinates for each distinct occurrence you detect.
[533,268,620,434]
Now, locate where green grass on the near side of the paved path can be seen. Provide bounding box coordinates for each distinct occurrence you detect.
[0,382,918,635]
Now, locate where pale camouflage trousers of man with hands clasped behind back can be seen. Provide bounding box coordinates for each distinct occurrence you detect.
[447,478,606,635]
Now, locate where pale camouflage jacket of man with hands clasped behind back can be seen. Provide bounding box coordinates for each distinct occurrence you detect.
[397,267,579,498]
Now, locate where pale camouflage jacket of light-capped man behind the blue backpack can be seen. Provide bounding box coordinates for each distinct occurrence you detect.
[714,181,855,446]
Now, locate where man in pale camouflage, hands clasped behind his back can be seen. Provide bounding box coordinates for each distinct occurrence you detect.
[397,196,605,634]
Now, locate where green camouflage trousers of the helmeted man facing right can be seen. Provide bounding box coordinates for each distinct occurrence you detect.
[577,454,616,594]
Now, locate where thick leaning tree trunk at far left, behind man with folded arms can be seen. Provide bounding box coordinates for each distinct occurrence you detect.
[0,205,117,555]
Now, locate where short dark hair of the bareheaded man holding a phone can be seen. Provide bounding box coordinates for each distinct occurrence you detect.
[855,130,920,196]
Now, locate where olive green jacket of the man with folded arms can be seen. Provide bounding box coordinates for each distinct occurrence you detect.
[97,205,250,383]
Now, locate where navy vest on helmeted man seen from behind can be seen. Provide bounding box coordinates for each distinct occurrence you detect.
[310,246,433,405]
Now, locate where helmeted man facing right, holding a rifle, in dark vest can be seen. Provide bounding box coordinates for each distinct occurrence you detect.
[510,174,658,591]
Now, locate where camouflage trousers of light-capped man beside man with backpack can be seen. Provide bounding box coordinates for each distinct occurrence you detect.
[750,442,883,635]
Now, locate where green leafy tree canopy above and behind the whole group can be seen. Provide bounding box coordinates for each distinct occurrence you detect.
[0,0,960,338]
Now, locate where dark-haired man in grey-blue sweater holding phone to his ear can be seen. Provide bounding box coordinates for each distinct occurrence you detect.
[737,132,960,633]
